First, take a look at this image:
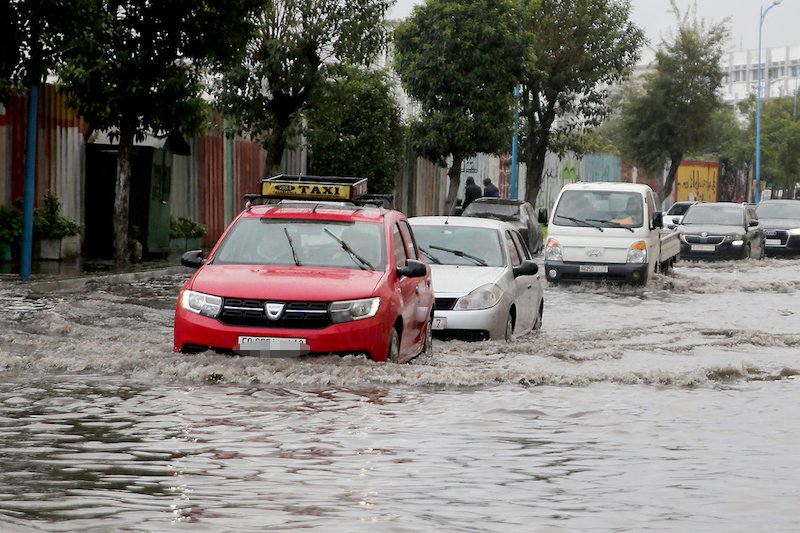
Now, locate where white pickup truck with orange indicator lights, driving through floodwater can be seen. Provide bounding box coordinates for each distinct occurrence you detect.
[544,182,681,285]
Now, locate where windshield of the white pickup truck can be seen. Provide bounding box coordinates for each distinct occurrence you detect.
[554,190,644,229]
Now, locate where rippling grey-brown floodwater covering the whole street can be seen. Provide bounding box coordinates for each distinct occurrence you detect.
[0,259,800,532]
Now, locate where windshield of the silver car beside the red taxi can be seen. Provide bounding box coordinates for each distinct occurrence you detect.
[414,225,505,267]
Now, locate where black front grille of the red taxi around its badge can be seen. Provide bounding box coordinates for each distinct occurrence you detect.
[219,298,332,329]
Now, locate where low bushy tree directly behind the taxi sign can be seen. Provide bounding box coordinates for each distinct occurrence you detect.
[306,68,404,193]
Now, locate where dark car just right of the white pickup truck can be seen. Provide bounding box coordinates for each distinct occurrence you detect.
[678,202,764,259]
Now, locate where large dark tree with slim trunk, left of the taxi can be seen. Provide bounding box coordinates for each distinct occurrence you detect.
[59,0,260,264]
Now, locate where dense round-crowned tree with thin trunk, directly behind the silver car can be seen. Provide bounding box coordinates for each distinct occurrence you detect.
[395,0,529,213]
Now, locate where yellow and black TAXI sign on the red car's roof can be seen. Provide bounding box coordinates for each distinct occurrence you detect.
[261,174,367,201]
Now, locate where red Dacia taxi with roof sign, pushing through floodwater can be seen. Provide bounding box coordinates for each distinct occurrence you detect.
[174,176,434,362]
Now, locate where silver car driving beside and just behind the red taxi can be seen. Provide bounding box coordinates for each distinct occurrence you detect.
[409,216,544,341]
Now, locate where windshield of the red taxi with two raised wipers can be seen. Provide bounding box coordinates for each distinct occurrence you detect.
[213,218,386,270]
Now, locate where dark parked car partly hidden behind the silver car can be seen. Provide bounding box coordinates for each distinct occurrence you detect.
[461,196,547,254]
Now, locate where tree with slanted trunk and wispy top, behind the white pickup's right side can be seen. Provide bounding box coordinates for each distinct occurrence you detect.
[621,0,728,201]
